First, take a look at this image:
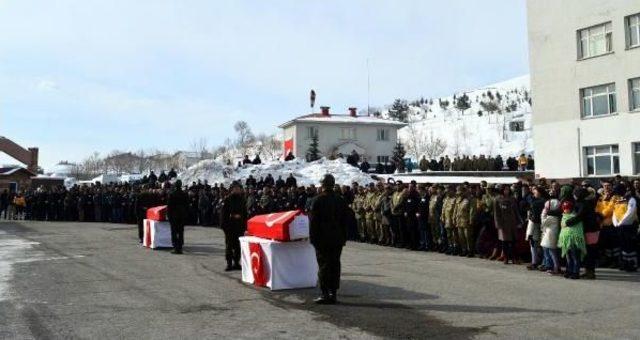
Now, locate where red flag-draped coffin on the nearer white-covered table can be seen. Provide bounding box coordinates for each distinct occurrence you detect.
[247,210,309,242]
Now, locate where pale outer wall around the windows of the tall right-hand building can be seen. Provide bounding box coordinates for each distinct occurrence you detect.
[527,0,640,178]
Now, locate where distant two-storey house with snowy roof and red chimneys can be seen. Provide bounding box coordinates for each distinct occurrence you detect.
[280,107,406,164]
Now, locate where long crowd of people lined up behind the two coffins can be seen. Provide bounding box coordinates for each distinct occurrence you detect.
[5,174,640,278]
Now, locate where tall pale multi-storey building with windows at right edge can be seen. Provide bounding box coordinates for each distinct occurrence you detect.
[527,0,640,178]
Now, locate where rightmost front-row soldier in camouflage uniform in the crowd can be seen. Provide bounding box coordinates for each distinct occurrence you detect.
[454,186,476,257]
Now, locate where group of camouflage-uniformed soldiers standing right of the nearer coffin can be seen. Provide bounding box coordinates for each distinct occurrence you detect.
[351,181,486,256]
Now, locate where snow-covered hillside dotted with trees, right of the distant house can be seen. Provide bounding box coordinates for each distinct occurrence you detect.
[392,75,533,159]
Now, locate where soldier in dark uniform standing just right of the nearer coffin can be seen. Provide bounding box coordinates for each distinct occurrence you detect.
[309,174,355,304]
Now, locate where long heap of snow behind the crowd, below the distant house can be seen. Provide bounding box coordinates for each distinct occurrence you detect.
[178,158,374,186]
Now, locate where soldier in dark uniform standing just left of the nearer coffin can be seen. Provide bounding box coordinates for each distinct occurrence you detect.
[220,182,247,271]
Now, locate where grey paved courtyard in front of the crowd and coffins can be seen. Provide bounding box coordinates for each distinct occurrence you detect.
[0,222,640,339]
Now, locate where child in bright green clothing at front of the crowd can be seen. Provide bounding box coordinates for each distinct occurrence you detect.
[558,200,587,280]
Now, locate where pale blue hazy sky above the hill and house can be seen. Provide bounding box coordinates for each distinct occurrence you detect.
[0,0,528,167]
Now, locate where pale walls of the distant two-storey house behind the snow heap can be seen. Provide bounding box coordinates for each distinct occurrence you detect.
[284,122,398,163]
